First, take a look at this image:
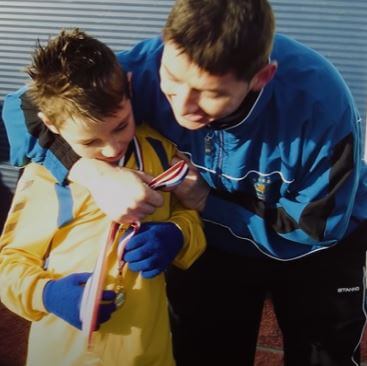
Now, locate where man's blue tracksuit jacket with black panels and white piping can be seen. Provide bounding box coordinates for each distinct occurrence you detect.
[3,34,367,260]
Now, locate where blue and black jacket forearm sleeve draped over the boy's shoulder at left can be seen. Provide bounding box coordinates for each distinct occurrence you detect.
[2,87,79,183]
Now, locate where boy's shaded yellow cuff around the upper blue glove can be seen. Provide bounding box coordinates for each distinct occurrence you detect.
[168,195,206,269]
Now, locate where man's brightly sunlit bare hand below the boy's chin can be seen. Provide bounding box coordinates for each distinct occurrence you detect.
[69,158,163,224]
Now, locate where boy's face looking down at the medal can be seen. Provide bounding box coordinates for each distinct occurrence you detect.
[58,98,135,164]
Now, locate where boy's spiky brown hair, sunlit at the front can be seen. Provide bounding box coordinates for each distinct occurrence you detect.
[27,28,129,126]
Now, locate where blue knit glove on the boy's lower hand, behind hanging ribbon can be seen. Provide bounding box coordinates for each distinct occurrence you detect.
[42,273,116,329]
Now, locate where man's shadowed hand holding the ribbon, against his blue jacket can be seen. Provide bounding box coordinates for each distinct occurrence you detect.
[171,156,210,212]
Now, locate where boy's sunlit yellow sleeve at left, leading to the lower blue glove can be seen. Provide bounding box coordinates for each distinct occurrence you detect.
[0,164,58,321]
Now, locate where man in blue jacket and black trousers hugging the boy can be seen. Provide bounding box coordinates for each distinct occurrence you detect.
[4,0,367,366]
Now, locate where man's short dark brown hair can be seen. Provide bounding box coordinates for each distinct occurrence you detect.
[163,0,275,81]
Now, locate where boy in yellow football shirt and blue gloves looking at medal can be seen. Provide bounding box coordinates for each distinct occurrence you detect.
[0,29,205,366]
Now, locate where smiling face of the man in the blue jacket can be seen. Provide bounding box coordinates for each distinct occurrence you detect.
[159,42,250,130]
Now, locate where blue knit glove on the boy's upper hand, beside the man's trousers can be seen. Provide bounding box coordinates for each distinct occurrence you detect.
[123,222,183,278]
